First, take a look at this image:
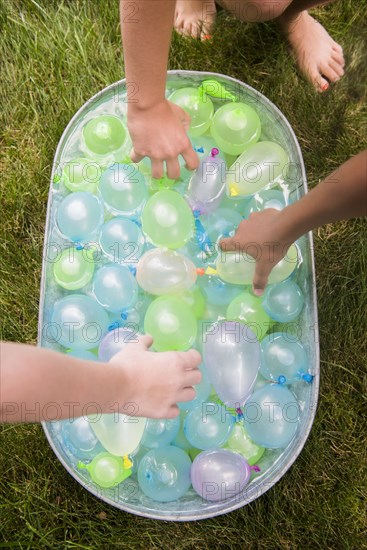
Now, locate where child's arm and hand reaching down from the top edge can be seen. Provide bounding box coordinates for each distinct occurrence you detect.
[120,0,199,179]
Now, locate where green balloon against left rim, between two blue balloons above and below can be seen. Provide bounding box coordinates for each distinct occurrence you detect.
[53,247,94,290]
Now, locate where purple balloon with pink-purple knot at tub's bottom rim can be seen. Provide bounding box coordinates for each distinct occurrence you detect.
[191,449,259,502]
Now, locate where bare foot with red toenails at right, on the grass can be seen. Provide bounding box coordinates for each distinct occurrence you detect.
[278,11,344,92]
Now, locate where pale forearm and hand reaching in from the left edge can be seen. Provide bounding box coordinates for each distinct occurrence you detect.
[0,336,201,422]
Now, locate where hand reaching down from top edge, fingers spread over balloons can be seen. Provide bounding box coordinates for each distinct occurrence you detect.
[128,99,199,179]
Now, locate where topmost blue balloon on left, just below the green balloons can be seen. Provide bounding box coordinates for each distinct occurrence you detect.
[99,163,148,216]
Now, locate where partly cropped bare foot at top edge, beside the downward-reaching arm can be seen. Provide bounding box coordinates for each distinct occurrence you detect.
[175,0,216,40]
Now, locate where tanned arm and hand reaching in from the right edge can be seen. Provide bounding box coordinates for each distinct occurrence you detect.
[220,150,367,295]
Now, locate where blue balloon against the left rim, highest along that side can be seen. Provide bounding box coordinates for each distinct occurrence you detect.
[56,192,103,242]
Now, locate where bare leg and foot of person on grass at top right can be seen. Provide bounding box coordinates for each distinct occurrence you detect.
[219,0,344,92]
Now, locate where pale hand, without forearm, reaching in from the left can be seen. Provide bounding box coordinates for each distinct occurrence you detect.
[110,335,201,418]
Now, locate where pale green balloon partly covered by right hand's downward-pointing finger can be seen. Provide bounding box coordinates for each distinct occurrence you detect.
[216,244,299,285]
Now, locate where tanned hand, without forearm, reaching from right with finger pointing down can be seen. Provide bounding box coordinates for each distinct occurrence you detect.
[219,208,293,296]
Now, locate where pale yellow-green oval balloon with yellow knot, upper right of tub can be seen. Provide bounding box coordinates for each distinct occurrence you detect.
[226,141,289,198]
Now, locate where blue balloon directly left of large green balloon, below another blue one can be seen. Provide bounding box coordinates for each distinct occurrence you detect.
[99,216,145,264]
